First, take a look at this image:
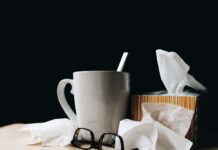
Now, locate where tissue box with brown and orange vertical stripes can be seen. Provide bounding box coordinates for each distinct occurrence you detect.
[131,91,199,145]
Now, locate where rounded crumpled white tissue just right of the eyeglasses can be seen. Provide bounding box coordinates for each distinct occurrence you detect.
[116,119,158,150]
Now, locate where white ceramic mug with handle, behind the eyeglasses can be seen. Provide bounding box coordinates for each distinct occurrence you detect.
[57,71,130,141]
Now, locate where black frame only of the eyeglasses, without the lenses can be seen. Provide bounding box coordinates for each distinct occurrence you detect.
[71,128,124,150]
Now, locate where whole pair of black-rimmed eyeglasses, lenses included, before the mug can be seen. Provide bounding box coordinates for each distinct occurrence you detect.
[71,128,124,150]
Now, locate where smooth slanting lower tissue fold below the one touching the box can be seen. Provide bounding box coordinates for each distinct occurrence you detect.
[142,109,192,150]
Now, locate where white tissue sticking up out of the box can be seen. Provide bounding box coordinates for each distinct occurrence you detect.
[156,49,206,94]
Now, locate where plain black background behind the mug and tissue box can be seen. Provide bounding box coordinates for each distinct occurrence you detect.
[0,1,218,147]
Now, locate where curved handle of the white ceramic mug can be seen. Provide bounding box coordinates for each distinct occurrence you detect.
[57,79,77,121]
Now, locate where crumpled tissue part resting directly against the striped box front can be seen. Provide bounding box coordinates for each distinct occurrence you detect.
[142,103,194,137]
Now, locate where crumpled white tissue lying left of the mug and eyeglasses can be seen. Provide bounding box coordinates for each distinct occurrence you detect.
[19,119,77,146]
